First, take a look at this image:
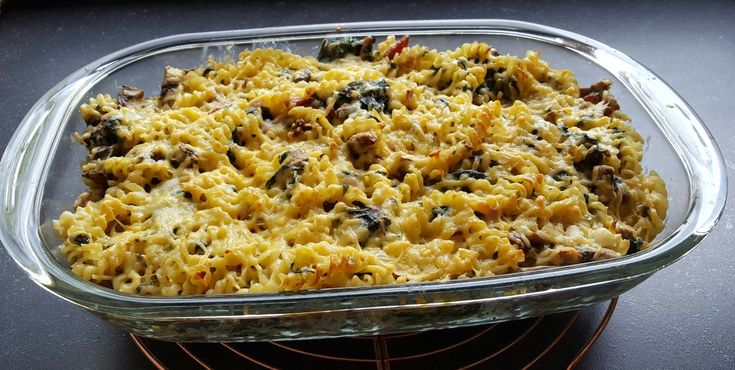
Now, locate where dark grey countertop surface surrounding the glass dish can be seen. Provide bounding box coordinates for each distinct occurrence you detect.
[0,0,735,369]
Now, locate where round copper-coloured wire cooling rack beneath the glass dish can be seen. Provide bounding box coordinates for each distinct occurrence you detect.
[131,298,617,370]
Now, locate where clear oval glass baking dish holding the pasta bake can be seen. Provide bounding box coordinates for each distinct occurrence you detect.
[0,20,727,341]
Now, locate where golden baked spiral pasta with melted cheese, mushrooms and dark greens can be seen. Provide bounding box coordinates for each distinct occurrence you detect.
[55,36,667,296]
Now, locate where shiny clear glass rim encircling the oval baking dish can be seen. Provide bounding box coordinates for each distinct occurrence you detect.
[0,19,727,312]
